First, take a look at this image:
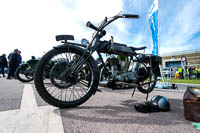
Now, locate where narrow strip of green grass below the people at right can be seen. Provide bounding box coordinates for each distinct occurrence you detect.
[160,78,200,84]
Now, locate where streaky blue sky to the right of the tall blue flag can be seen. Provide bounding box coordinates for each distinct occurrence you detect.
[160,0,200,53]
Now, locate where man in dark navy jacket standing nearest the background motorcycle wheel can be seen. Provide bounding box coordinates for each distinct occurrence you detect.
[7,49,19,79]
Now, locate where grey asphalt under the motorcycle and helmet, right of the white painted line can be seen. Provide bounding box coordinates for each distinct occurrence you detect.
[61,89,198,133]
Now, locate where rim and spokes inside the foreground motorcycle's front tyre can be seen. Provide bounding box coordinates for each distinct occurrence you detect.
[43,52,94,103]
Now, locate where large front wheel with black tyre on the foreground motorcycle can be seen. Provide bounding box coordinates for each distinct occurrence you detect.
[34,46,99,108]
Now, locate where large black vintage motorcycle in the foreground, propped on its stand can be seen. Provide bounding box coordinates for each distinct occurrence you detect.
[34,13,161,108]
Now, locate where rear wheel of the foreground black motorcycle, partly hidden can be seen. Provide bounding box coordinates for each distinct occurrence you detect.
[138,73,157,94]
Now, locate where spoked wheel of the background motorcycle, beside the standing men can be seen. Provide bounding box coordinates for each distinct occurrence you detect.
[15,65,34,82]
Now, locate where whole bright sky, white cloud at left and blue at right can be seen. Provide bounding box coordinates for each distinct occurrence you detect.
[0,0,200,60]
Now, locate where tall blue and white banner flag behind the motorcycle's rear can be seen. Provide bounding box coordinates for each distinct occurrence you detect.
[148,0,159,55]
